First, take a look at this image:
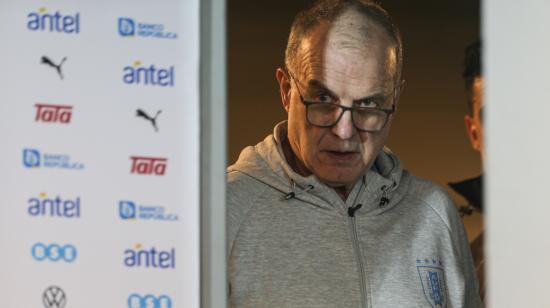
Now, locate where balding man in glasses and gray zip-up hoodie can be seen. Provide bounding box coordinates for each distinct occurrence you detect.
[227,0,480,307]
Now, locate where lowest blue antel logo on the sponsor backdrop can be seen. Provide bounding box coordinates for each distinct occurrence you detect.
[124,244,176,269]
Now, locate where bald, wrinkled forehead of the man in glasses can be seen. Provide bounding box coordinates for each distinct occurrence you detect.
[294,17,397,94]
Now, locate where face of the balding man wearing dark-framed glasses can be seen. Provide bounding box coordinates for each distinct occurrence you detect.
[278,19,398,190]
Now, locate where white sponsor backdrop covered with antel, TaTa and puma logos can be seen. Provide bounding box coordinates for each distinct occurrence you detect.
[0,0,200,308]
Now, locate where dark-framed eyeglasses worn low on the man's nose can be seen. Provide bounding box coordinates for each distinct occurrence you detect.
[288,72,395,133]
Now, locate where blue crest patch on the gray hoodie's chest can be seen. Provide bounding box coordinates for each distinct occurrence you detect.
[416,259,447,308]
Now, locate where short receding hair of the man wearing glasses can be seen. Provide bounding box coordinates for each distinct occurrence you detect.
[285,0,403,82]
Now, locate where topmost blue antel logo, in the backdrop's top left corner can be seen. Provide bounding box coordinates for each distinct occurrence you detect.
[27,7,80,34]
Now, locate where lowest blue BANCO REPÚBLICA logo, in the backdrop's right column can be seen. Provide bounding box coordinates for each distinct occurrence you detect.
[118,200,178,221]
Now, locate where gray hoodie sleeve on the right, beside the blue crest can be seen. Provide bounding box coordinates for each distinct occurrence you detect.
[424,181,483,308]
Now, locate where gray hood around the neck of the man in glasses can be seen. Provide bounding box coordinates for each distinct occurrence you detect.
[228,121,409,215]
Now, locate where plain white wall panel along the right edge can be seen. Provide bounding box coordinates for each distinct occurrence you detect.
[490,0,550,308]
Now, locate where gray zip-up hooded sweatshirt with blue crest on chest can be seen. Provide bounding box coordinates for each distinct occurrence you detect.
[227,122,481,308]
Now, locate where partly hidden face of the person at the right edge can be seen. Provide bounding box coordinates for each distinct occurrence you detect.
[464,77,485,161]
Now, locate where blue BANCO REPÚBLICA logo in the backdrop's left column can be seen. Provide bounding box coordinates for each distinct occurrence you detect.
[23,149,84,170]
